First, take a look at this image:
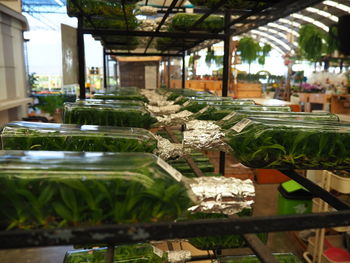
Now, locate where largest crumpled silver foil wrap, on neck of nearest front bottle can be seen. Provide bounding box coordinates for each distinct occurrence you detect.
[188,176,255,215]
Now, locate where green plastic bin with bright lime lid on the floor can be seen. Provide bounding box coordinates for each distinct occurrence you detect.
[278,180,313,215]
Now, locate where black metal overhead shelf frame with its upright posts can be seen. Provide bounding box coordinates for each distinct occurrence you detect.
[71,0,321,99]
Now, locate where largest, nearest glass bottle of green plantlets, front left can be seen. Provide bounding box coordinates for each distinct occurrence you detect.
[0,152,192,229]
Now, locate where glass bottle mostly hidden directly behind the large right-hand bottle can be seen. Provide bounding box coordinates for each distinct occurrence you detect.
[216,111,339,129]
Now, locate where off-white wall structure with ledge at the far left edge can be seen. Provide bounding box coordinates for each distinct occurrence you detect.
[0,4,30,125]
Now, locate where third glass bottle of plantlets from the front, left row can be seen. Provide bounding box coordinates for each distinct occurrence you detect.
[63,103,157,128]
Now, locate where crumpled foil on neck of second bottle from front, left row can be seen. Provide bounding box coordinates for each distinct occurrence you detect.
[155,135,188,160]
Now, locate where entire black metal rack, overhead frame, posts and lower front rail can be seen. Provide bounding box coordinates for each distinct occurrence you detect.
[4,0,350,262]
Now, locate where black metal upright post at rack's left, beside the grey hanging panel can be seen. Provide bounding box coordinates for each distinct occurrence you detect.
[77,17,86,100]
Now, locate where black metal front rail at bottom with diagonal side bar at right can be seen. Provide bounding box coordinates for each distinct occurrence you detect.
[0,170,350,248]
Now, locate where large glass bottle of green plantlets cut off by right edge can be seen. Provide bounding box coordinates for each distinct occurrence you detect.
[225,118,350,170]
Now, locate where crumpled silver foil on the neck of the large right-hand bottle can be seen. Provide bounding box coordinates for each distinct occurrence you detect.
[183,120,230,152]
